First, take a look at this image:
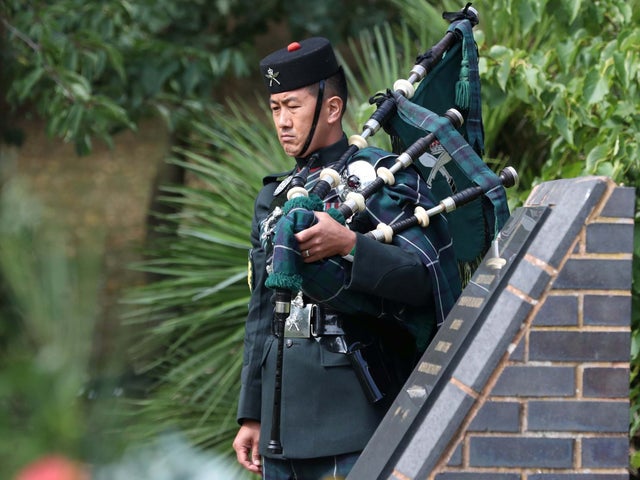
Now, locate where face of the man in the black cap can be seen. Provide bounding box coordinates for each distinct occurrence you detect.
[269,88,318,157]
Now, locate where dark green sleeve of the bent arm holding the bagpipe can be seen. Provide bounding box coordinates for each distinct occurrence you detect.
[346,233,432,306]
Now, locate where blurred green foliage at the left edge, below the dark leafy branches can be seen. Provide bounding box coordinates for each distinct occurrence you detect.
[0,179,122,478]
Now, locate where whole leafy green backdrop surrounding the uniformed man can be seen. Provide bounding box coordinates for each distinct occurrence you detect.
[0,0,640,480]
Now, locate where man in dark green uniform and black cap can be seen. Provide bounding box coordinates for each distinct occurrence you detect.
[233,6,510,480]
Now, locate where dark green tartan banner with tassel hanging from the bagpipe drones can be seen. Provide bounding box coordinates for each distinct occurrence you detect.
[386,19,509,264]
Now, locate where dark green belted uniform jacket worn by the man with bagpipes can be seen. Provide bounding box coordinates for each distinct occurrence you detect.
[238,138,434,458]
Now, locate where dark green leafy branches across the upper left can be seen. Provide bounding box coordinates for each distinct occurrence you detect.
[0,0,400,154]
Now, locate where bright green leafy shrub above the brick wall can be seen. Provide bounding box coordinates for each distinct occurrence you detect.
[478,0,640,194]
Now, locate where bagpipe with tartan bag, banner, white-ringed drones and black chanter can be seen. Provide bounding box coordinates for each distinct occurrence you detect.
[265,4,518,453]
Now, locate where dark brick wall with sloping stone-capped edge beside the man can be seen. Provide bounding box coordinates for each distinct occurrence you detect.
[348,177,635,480]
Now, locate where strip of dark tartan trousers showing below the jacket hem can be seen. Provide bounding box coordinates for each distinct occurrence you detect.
[262,452,360,480]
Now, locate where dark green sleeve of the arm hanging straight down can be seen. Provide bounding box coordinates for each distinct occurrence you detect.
[237,186,273,423]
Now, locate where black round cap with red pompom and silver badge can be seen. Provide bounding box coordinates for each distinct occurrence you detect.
[260,37,340,93]
